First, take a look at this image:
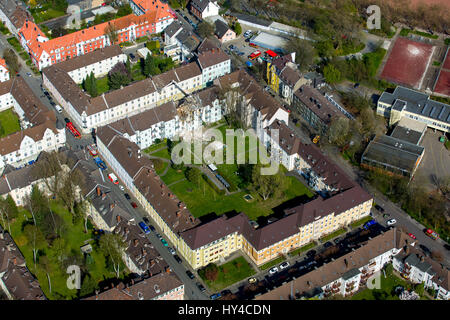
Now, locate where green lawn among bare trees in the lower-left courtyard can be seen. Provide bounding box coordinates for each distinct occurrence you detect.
[6,202,125,300]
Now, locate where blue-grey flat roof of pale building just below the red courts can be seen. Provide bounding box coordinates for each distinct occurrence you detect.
[379,86,450,124]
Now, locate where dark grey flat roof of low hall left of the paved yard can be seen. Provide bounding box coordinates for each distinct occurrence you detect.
[362,135,425,172]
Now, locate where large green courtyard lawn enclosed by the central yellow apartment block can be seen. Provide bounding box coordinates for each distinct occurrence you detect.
[145,124,313,221]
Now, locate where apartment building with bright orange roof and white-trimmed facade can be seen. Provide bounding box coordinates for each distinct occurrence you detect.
[18,7,173,70]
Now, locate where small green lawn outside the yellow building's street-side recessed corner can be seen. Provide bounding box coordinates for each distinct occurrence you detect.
[198,257,256,292]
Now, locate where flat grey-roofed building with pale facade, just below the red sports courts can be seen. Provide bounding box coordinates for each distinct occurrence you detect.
[377,86,450,133]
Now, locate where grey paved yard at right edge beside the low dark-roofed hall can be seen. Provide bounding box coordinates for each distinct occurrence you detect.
[413,129,450,190]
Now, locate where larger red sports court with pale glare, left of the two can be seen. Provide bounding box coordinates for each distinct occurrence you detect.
[381,37,434,89]
